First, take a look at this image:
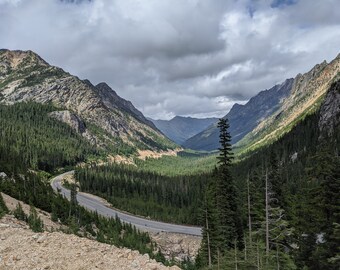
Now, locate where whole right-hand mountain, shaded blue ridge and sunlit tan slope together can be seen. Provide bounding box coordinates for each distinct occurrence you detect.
[183,55,340,153]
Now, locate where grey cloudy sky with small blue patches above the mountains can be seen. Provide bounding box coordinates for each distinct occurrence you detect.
[0,0,340,119]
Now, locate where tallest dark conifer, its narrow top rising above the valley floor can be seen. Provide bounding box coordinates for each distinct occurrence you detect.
[197,118,242,267]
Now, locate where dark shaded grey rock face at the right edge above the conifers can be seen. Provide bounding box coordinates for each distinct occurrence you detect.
[319,80,340,138]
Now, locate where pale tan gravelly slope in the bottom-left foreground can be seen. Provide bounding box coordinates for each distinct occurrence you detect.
[0,215,179,270]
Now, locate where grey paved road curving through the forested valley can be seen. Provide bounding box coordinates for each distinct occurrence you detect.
[51,171,202,236]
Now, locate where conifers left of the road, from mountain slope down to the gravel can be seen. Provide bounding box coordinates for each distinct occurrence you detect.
[0,102,171,263]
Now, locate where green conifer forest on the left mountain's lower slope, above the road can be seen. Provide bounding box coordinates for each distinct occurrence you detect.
[0,102,97,173]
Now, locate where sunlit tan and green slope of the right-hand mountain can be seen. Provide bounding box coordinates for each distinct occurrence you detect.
[235,55,340,152]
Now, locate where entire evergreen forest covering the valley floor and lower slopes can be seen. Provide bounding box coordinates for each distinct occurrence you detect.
[0,80,340,270]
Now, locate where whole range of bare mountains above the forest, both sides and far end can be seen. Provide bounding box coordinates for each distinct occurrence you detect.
[0,49,340,154]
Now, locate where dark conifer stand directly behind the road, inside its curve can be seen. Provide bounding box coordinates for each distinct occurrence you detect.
[75,164,207,224]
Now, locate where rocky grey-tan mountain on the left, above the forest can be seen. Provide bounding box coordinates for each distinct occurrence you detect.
[0,49,176,154]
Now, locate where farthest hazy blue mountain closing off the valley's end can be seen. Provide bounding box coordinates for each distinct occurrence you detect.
[151,116,218,144]
